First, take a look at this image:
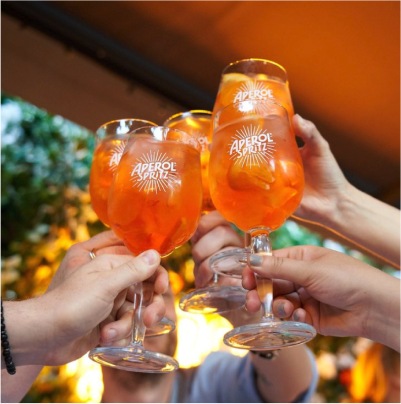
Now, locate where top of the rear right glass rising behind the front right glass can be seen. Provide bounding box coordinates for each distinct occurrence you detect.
[213,59,294,118]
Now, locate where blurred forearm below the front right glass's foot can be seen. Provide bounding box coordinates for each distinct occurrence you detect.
[250,346,313,403]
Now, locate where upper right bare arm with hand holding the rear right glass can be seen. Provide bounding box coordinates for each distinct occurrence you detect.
[293,115,400,268]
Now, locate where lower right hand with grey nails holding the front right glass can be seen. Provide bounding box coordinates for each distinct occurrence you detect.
[243,246,400,349]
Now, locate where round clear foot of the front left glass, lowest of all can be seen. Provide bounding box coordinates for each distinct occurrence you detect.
[89,347,179,373]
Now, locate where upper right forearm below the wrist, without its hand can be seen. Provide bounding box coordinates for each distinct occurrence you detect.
[322,185,400,267]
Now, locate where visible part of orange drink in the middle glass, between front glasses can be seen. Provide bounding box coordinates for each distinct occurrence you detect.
[164,110,214,213]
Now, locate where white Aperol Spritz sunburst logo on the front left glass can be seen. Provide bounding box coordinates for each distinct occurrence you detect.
[131,151,177,193]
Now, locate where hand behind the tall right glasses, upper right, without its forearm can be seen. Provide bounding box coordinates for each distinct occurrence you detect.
[293,115,351,225]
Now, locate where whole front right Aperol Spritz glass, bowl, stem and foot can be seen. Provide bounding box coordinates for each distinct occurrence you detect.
[209,100,316,350]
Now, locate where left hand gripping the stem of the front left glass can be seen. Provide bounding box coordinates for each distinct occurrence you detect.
[35,231,168,365]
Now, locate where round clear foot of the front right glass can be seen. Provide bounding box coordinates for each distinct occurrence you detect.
[224,320,316,351]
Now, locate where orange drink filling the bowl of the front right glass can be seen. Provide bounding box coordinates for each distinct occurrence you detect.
[209,101,304,232]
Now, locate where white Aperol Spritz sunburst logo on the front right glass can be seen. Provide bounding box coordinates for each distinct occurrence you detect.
[229,125,275,166]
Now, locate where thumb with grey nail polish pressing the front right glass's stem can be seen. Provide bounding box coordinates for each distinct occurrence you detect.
[249,254,312,286]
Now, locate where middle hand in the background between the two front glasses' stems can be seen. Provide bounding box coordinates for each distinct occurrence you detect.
[191,211,244,287]
